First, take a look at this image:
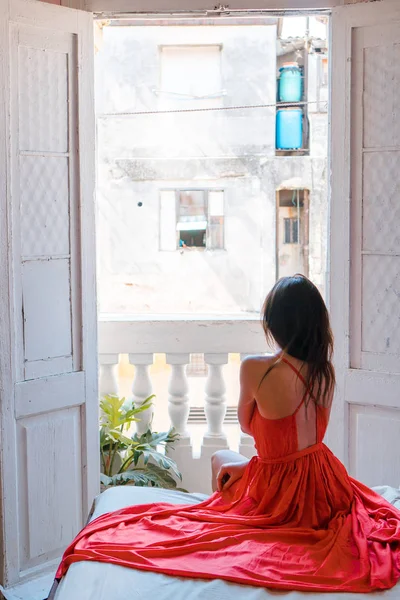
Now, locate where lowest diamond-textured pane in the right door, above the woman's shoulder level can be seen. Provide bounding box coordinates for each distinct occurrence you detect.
[362,256,400,355]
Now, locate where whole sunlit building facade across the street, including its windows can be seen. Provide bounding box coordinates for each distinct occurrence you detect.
[96,19,328,315]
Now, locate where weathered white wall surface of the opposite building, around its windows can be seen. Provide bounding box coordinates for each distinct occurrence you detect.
[96,26,327,313]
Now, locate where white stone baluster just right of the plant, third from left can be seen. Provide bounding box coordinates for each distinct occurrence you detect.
[166,354,190,439]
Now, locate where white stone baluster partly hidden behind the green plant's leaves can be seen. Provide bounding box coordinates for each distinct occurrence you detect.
[129,354,154,435]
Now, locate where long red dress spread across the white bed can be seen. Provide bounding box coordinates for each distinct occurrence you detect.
[57,363,400,592]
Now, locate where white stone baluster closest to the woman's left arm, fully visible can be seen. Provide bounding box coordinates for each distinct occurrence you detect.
[201,353,228,460]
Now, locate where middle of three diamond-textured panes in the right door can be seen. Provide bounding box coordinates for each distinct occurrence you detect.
[363,152,400,252]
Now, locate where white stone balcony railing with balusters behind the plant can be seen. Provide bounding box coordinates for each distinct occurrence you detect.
[99,315,267,493]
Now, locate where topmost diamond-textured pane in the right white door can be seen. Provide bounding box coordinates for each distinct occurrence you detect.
[364,44,400,148]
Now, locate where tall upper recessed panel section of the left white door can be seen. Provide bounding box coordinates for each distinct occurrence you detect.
[11,23,80,379]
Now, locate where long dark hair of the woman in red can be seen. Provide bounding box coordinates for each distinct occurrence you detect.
[262,275,335,405]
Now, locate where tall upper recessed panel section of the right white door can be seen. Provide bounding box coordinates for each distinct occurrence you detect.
[350,22,400,376]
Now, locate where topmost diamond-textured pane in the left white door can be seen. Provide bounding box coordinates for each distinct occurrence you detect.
[18,46,68,152]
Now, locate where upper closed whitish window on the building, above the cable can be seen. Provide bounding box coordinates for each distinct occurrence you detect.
[157,45,224,110]
